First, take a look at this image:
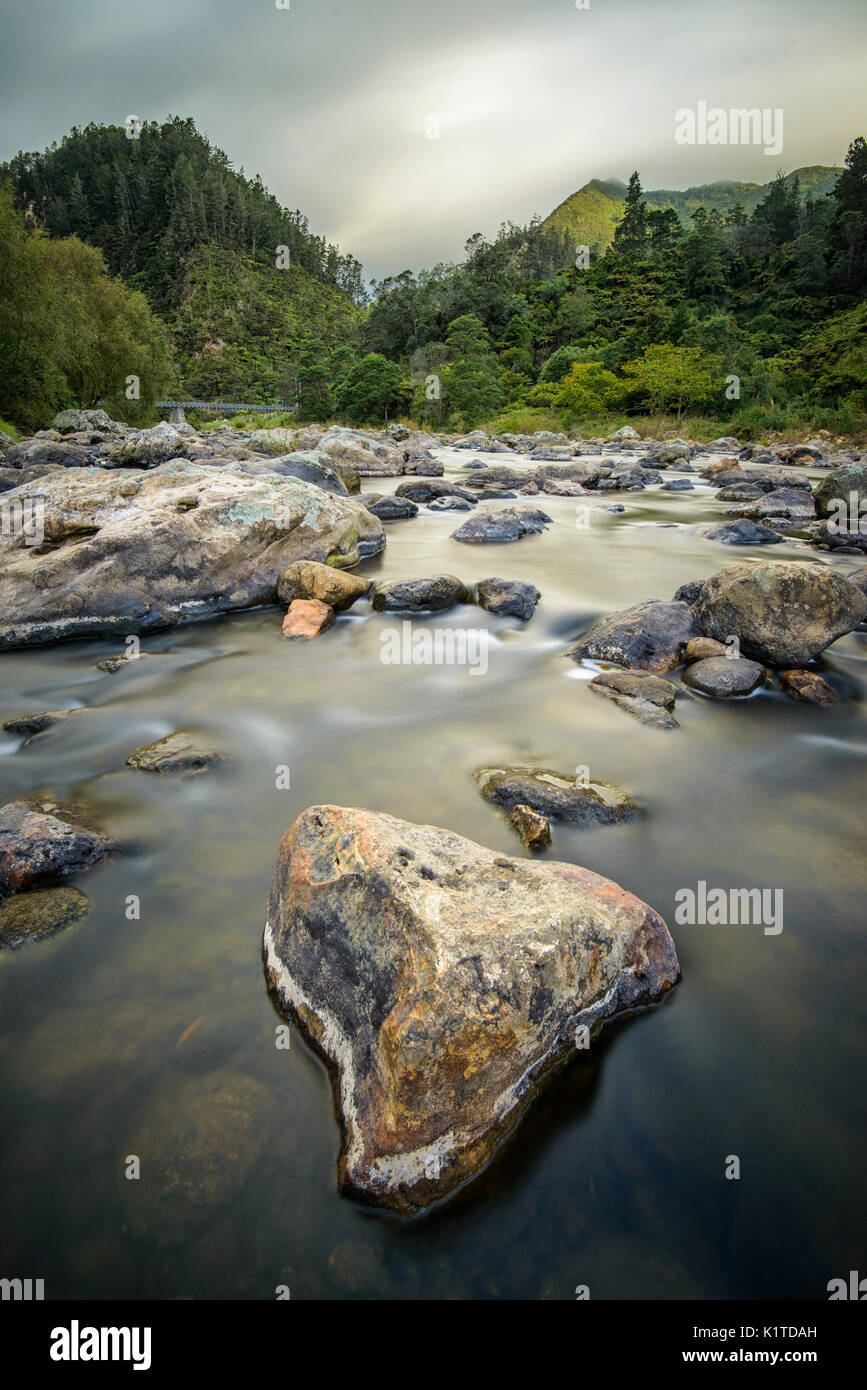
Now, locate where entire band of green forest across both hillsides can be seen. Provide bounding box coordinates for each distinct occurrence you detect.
[0,118,867,431]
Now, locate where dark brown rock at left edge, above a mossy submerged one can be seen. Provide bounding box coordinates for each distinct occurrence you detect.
[0,796,115,897]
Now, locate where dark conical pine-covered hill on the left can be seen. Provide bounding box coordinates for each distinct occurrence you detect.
[0,117,365,414]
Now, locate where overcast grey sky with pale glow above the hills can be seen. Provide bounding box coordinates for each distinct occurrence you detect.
[0,0,867,277]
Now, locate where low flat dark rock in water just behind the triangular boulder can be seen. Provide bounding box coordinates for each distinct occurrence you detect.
[475,767,641,827]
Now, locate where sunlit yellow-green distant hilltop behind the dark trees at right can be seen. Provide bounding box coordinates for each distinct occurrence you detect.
[542,164,842,252]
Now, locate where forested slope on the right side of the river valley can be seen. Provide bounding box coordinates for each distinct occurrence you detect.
[365,139,867,428]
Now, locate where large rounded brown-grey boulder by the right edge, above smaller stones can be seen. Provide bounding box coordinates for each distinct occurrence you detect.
[692,560,867,666]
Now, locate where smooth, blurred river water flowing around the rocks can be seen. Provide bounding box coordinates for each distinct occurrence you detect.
[0,450,867,1298]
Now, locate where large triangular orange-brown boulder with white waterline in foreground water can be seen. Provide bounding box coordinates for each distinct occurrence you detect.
[264,806,679,1213]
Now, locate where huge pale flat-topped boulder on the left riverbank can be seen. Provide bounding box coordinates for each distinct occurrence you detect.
[0,459,385,649]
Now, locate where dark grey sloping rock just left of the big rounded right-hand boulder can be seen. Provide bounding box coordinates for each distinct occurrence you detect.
[564,599,702,673]
